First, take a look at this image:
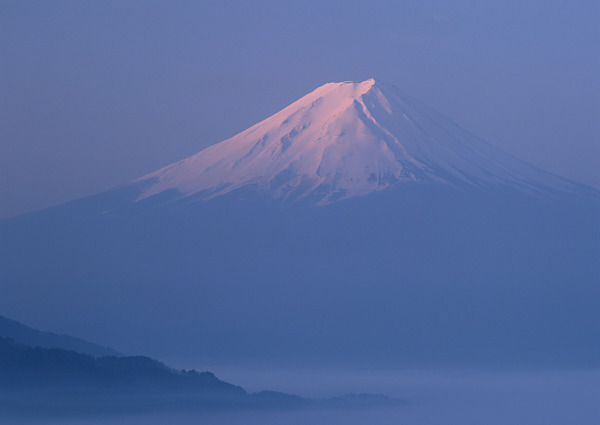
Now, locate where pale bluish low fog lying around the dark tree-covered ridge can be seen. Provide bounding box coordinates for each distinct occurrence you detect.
[7,366,600,425]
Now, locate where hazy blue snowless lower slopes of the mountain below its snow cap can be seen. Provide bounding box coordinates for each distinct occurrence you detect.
[0,183,600,367]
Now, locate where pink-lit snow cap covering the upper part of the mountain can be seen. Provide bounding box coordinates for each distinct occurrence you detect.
[136,79,577,204]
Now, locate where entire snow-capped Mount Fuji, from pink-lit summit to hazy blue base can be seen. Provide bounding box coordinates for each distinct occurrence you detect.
[0,80,600,368]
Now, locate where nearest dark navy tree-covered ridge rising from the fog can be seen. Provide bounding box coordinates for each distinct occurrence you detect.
[0,337,328,419]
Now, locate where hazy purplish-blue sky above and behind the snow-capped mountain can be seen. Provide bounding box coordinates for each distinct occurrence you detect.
[0,0,600,217]
